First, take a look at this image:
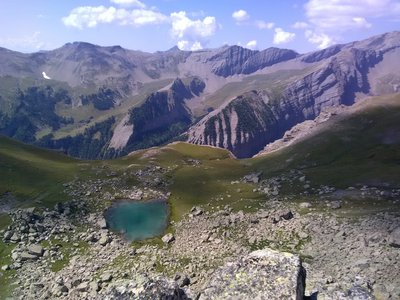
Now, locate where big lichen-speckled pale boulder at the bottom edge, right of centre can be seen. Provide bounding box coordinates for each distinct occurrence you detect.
[200,249,306,300]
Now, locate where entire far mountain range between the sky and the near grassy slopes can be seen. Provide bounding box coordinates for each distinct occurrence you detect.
[0,32,400,158]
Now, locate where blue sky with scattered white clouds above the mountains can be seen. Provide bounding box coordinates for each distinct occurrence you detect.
[0,0,400,53]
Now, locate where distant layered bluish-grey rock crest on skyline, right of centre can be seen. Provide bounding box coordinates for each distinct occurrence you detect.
[208,46,298,77]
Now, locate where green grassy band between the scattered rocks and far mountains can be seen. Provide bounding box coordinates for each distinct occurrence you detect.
[0,95,400,212]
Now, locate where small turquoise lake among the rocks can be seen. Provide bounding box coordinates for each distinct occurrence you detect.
[105,200,168,241]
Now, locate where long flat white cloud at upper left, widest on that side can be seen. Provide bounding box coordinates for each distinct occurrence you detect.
[62,6,168,29]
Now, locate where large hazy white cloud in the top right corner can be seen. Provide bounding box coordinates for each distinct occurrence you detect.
[305,0,400,32]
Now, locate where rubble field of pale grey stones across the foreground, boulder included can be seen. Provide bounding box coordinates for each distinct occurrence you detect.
[1,169,400,300]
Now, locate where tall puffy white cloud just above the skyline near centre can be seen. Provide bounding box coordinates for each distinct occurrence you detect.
[170,11,217,42]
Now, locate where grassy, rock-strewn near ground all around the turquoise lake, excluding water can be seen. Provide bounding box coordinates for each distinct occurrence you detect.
[0,94,400,299]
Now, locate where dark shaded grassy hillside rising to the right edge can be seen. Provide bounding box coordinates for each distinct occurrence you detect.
[252,95,400,188]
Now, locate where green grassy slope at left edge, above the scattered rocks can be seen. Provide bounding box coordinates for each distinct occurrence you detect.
[0,136,79,205]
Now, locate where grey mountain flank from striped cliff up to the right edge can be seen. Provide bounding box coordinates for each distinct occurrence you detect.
[188,33,400,157]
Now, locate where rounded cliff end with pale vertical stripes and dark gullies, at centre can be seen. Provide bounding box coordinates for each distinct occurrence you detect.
[188,91,280,157]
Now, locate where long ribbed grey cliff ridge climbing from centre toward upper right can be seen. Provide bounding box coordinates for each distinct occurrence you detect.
[188,37,396,158]
